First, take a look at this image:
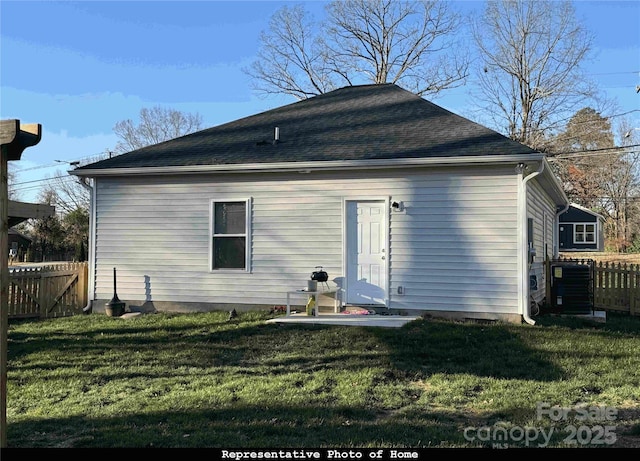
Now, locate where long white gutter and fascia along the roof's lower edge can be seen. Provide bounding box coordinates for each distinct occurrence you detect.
[74,154,544,177]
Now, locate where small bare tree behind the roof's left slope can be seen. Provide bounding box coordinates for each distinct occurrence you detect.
[113,106,202,153]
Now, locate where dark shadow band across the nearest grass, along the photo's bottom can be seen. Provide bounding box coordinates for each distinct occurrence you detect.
[8,404,640,449]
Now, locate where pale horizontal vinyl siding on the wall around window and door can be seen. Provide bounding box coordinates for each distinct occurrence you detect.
[90,166,518,314]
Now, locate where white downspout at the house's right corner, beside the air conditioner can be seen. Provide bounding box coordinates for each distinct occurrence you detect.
[516,161,544,325]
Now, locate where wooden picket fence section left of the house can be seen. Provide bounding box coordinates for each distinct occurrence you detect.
[9,262,88,318]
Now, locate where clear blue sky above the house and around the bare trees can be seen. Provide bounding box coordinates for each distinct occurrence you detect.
[0,0,640,201]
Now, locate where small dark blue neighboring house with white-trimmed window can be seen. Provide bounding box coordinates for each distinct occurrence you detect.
[558,203,604,251]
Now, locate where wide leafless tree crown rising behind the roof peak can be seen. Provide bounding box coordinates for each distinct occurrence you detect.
[245,0,469,99]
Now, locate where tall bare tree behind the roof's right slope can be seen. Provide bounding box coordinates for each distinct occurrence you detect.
[473,0,595,148]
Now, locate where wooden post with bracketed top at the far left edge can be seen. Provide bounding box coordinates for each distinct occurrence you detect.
[0,120,42,448]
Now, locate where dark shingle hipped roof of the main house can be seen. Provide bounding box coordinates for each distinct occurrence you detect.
[76,84,535,171]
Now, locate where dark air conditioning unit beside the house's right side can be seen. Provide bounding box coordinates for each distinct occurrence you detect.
[550,262,594,314]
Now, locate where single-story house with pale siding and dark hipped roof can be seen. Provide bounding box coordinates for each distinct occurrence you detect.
[71,84,568,322]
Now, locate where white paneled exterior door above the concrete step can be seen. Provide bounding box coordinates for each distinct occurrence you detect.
[346,200,387,305]
